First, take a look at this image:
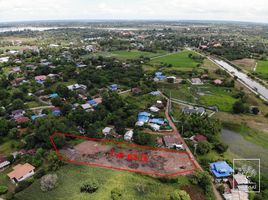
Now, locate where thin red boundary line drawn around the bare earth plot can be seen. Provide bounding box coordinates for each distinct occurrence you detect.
[49,132,197,177]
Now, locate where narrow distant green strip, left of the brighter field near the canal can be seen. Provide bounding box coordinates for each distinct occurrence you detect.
[111,50,167,59]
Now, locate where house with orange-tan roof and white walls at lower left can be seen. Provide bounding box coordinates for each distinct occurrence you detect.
[7,163,35,183]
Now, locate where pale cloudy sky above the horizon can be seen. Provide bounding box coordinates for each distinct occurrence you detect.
[0,0,268,23]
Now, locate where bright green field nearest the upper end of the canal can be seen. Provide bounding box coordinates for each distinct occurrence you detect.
[150,50,202,69]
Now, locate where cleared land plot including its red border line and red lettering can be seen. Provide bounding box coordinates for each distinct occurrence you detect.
[50,133,196,176]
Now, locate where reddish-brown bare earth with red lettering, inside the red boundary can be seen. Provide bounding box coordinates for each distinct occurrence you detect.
[60,141,195,175]
